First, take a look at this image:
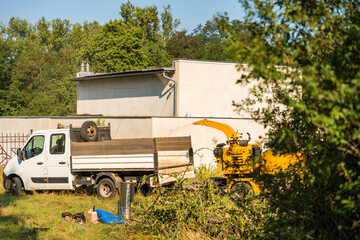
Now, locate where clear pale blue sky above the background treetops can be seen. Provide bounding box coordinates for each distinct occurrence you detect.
[0,0,245,32]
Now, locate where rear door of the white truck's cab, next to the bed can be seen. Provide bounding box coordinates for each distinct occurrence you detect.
[46,133,72,189]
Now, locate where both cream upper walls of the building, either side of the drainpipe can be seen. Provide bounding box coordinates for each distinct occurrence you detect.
[77,60,262,118]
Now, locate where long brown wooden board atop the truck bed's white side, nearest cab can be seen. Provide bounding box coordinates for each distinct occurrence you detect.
[71,138,155,156]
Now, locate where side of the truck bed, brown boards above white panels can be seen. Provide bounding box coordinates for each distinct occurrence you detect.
[71,136,193,174]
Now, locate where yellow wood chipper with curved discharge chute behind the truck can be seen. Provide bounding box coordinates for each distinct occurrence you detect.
[193,119,299,197]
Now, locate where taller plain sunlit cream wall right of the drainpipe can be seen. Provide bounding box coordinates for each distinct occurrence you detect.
[174,60,250,118]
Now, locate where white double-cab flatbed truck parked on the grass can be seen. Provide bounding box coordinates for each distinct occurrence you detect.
[3,122,194,198]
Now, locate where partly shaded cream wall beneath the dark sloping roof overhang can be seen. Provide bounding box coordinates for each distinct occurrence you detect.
[77,75,174,116]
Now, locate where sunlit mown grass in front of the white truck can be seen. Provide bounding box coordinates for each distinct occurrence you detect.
[0,170,161,239]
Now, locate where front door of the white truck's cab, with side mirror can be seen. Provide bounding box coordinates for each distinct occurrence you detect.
[19,135,46,190]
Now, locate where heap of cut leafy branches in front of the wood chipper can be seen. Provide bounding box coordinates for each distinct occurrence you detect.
[135,177,270,239]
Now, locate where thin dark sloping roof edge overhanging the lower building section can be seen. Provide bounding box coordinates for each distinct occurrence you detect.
[69,67,175,81]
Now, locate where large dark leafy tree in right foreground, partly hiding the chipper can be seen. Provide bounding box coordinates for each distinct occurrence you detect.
[218,0,360,239]
